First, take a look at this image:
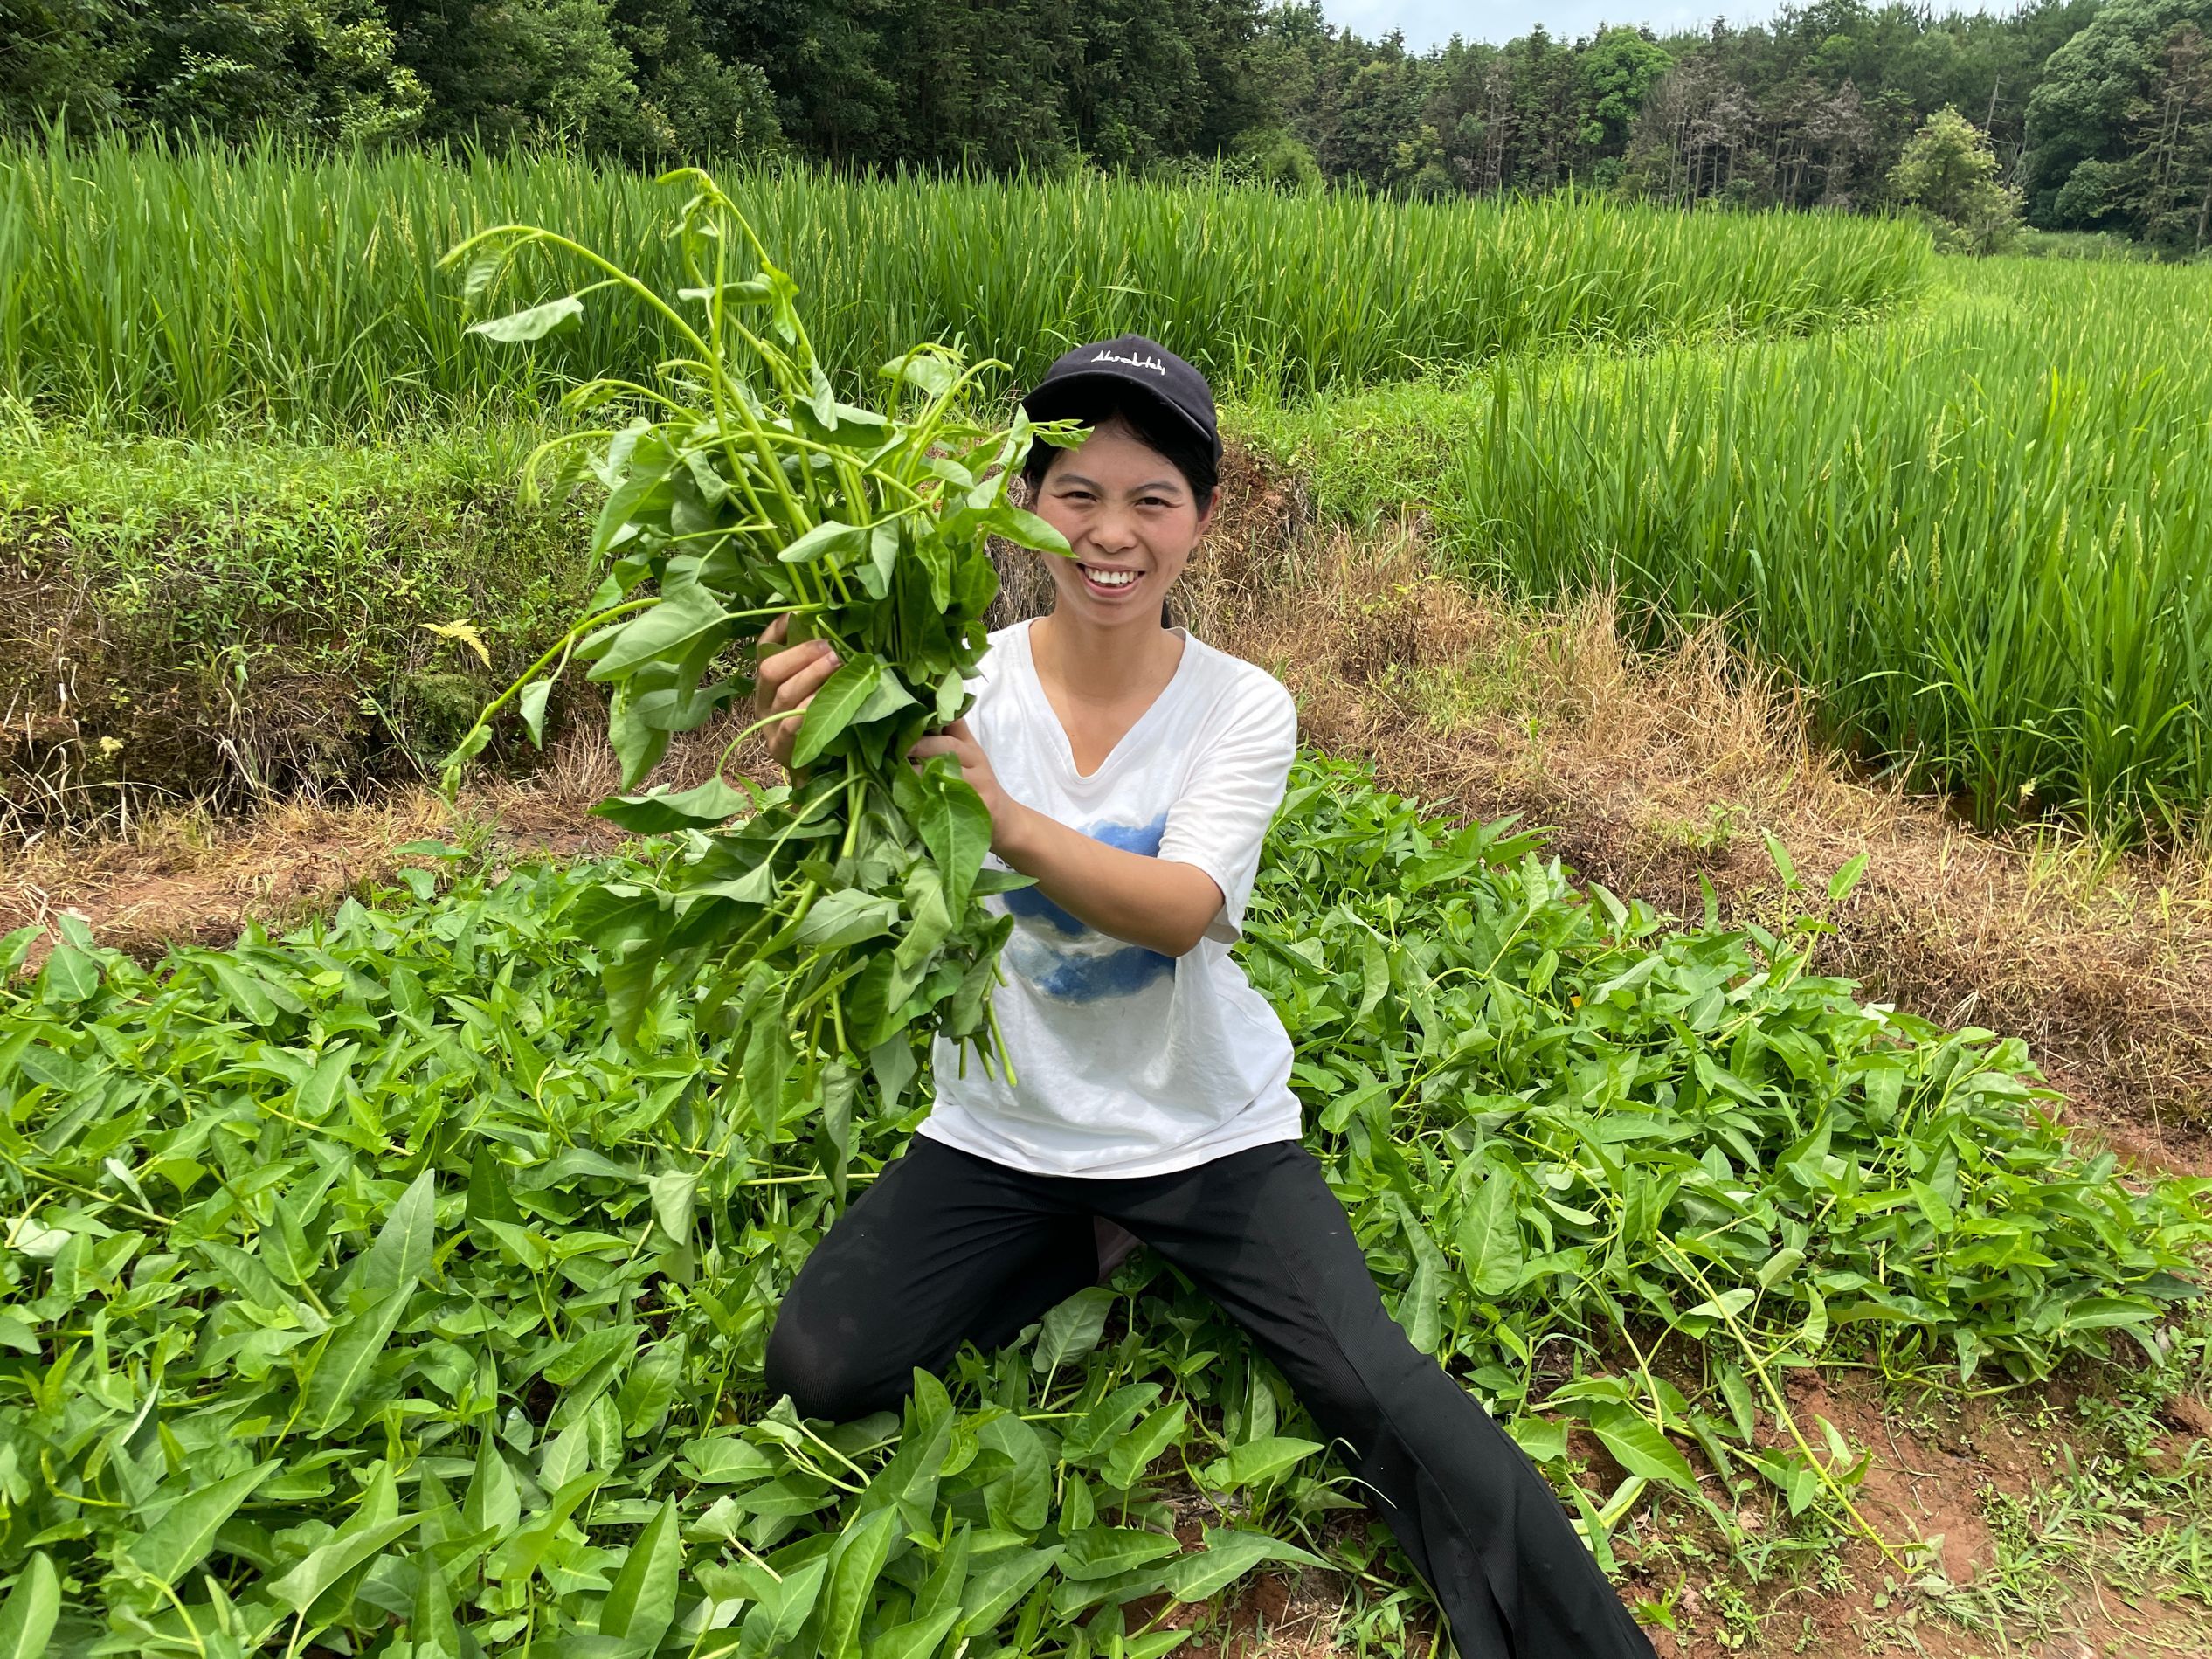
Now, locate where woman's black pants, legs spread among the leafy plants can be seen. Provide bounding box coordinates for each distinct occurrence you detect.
[768,1139,1652,1659]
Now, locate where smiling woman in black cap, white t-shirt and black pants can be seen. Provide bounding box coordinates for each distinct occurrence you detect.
[758,336,1652,1659]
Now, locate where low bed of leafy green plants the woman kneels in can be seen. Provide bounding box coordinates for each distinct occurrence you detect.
[0,761,2212,1659]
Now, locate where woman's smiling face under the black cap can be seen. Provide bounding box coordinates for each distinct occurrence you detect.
[1035,420,1213,628]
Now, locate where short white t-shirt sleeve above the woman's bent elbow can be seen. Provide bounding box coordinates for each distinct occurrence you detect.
[1159,677,1298,944]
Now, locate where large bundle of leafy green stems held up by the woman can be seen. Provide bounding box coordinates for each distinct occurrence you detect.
[445,168,1073,1188]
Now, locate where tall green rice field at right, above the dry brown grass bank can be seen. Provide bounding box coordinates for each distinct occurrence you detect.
[1259,261,2212,845]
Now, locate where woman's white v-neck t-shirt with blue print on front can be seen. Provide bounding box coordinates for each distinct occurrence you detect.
[918,621,1301,1177]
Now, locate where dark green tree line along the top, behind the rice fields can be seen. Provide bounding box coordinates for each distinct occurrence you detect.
[0,0,2212,252]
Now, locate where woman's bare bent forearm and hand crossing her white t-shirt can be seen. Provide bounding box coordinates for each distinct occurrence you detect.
[911,721,1221,956]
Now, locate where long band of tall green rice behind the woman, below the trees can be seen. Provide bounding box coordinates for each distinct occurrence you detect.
[0,142,1929,432]
